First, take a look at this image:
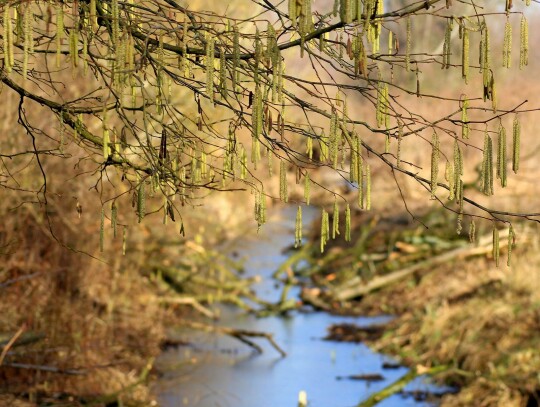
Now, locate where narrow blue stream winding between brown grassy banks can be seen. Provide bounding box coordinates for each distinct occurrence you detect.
[154,207,450,407]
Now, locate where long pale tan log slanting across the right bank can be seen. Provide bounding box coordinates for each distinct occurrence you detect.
[331,231,508,301]
